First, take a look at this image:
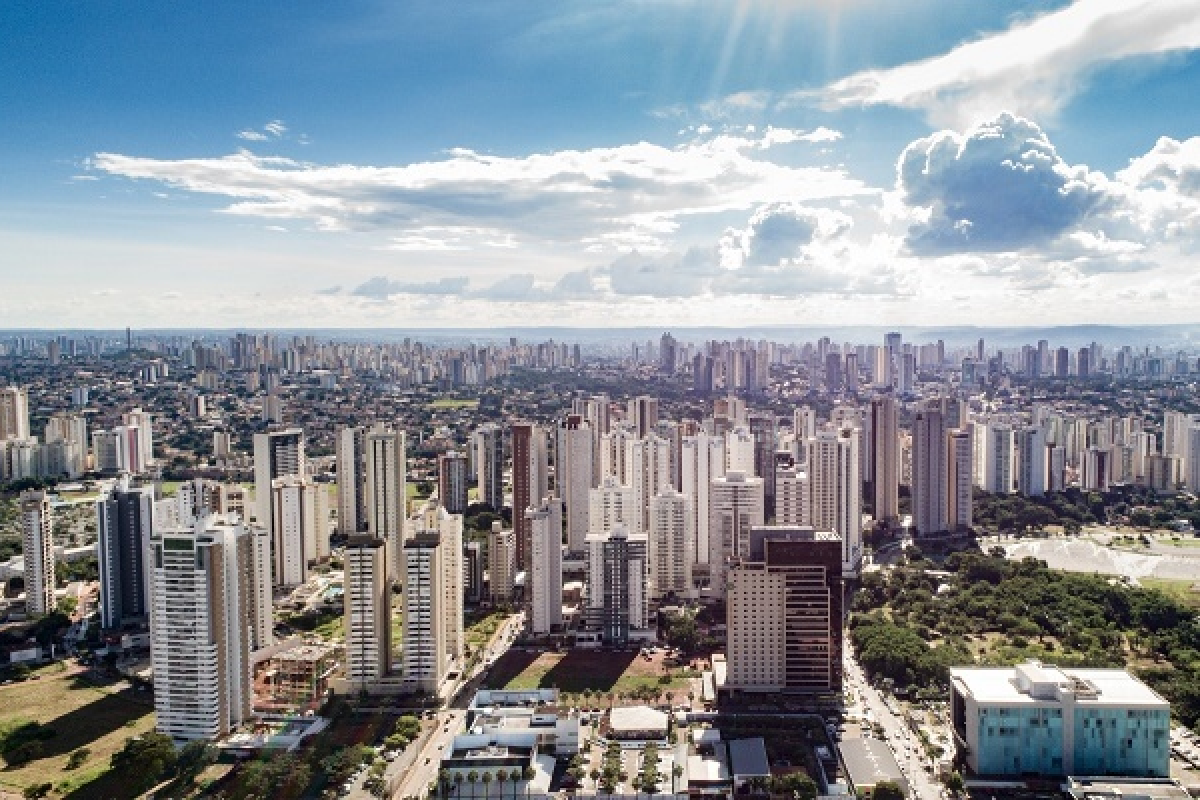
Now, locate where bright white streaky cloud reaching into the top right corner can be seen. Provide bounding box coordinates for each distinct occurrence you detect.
[792,0,1200,127]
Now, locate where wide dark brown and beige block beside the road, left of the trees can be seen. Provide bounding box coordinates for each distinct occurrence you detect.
[718,527,842,694]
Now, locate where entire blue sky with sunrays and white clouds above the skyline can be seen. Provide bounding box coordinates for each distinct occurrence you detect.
[0,0,1200,329]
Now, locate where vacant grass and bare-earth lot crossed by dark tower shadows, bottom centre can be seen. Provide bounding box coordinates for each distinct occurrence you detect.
[487,650,688,694]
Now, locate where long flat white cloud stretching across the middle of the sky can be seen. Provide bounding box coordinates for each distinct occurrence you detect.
[91,128,875,248]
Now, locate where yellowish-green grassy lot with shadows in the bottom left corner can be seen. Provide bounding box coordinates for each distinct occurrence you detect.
[0,663,154,796]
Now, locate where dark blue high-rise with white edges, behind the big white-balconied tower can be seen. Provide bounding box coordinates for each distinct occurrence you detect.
[96,476,154,631]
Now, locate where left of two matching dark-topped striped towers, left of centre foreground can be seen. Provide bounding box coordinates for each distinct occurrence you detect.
[343,534,391,690]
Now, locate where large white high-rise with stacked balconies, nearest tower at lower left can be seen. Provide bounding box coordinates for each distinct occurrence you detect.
[149,516,258,741]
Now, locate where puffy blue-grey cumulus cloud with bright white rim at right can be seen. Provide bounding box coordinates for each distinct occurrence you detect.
[896,113,1104,253]
